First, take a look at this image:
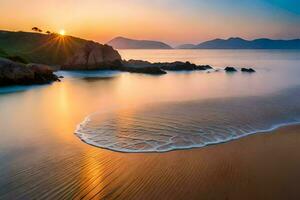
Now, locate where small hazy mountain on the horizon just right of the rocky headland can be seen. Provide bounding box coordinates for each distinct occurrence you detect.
[107,37,172,49]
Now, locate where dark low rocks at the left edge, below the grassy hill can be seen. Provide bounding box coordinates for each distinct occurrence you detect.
[0,58,59,86]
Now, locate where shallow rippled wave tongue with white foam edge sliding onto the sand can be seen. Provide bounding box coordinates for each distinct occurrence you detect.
[75,89,300,153]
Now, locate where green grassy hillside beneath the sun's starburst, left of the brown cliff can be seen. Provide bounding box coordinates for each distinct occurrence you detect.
[0,31,92,65]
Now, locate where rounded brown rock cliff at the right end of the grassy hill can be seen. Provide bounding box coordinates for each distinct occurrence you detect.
[62,41,121,70]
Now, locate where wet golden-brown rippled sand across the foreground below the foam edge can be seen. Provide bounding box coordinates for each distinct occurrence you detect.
[0,126,300,200]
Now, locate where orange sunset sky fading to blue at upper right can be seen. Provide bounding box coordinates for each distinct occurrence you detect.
[0,0,300,45]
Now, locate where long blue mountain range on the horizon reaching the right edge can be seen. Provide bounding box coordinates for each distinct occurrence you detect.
[178,38,300,49]
